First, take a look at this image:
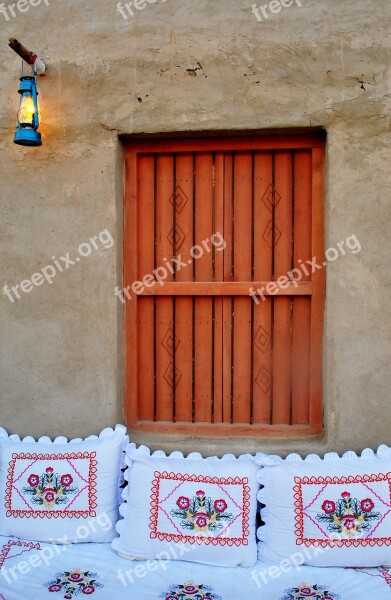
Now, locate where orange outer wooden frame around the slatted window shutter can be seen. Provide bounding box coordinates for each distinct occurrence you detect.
[124,133,325,438]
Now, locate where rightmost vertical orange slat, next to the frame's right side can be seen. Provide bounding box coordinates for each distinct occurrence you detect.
[292,151,312,425]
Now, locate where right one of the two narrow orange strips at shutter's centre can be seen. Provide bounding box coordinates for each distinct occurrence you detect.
[222,153,233,423]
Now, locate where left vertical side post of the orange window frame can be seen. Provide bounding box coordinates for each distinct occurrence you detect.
[124,153,138,424]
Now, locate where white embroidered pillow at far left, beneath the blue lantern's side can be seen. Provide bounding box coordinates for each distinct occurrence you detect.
[0,425,128,543]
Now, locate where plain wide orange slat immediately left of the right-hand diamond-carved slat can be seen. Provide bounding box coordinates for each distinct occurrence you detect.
[233,153,252,423]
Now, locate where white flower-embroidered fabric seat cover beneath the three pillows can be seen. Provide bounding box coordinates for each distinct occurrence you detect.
[0,537,391,600]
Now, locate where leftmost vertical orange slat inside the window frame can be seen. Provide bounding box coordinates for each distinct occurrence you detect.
[138,156,155,421]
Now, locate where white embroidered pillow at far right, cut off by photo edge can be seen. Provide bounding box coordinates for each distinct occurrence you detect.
[257,446,391,567]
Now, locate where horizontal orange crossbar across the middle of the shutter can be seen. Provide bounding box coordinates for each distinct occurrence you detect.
[139,281,312,300]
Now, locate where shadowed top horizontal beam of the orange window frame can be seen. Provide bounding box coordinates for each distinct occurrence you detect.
[126,134,324,154]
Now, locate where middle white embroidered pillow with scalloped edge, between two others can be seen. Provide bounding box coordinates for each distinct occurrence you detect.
[112,444,259,566]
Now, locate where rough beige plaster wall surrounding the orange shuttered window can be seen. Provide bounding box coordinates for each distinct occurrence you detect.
[0,0,391,453]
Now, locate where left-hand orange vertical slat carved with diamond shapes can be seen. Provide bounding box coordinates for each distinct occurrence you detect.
[175,154,193,423]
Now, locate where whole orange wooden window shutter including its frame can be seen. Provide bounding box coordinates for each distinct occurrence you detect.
[124,136,325,435]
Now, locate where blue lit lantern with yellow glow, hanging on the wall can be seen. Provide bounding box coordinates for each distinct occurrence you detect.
[14,72,42,146]
